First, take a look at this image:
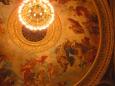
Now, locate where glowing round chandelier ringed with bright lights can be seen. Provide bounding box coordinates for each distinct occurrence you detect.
[18,0,54,31]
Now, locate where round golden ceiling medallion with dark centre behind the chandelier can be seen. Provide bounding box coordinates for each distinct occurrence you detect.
[7,9,62,52]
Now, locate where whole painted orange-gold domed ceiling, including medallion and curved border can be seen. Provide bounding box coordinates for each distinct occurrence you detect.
[0,0,113,86]
